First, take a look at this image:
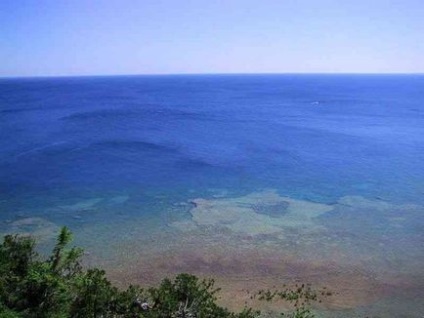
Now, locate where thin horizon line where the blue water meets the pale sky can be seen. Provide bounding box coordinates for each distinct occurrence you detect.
[0,72,424,79]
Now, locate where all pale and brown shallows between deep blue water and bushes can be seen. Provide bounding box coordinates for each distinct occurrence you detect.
[1,190,424,317]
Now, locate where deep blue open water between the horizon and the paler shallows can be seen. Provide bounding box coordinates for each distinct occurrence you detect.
[0,75,424,316]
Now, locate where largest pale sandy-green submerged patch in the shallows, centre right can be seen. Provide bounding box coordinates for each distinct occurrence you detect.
[171,190,333,236]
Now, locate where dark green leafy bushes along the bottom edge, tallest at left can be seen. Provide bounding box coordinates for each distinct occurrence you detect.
[0,227,316,318]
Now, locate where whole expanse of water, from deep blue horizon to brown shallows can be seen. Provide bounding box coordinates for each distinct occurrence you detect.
[0,75,424,317]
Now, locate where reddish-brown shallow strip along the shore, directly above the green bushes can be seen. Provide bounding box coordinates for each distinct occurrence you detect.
[100,243,423,313]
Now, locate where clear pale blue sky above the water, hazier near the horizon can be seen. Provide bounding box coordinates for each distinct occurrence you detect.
[0,0,424,76]
